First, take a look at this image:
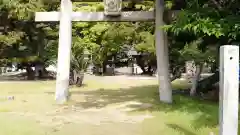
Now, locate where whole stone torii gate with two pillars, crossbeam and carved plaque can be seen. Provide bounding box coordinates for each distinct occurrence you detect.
[35,0,172,103]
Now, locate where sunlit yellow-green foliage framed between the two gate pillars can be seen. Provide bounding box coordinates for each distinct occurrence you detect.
[70,2,155,66]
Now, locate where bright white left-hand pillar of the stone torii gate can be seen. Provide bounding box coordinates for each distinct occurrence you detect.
[55,0,72,103]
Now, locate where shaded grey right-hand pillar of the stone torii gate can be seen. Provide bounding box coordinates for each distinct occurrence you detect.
[155,0,172,103]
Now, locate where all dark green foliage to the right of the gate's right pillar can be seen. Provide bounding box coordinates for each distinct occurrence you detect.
[163,0,240,75]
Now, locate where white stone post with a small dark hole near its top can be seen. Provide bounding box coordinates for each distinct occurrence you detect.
[219,45,239,135]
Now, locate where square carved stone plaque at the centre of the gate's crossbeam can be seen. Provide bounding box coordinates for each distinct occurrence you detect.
[103,0,122,16]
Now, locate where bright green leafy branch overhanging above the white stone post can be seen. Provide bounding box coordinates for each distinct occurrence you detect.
[164,0,240,43]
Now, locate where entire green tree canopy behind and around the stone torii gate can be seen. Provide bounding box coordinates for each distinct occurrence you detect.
[0,0,240,79]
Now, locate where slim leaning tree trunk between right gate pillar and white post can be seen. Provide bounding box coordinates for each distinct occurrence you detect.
[190,64,203,96]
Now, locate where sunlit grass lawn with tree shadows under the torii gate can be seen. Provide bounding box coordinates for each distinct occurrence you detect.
[0,80,221,135]
